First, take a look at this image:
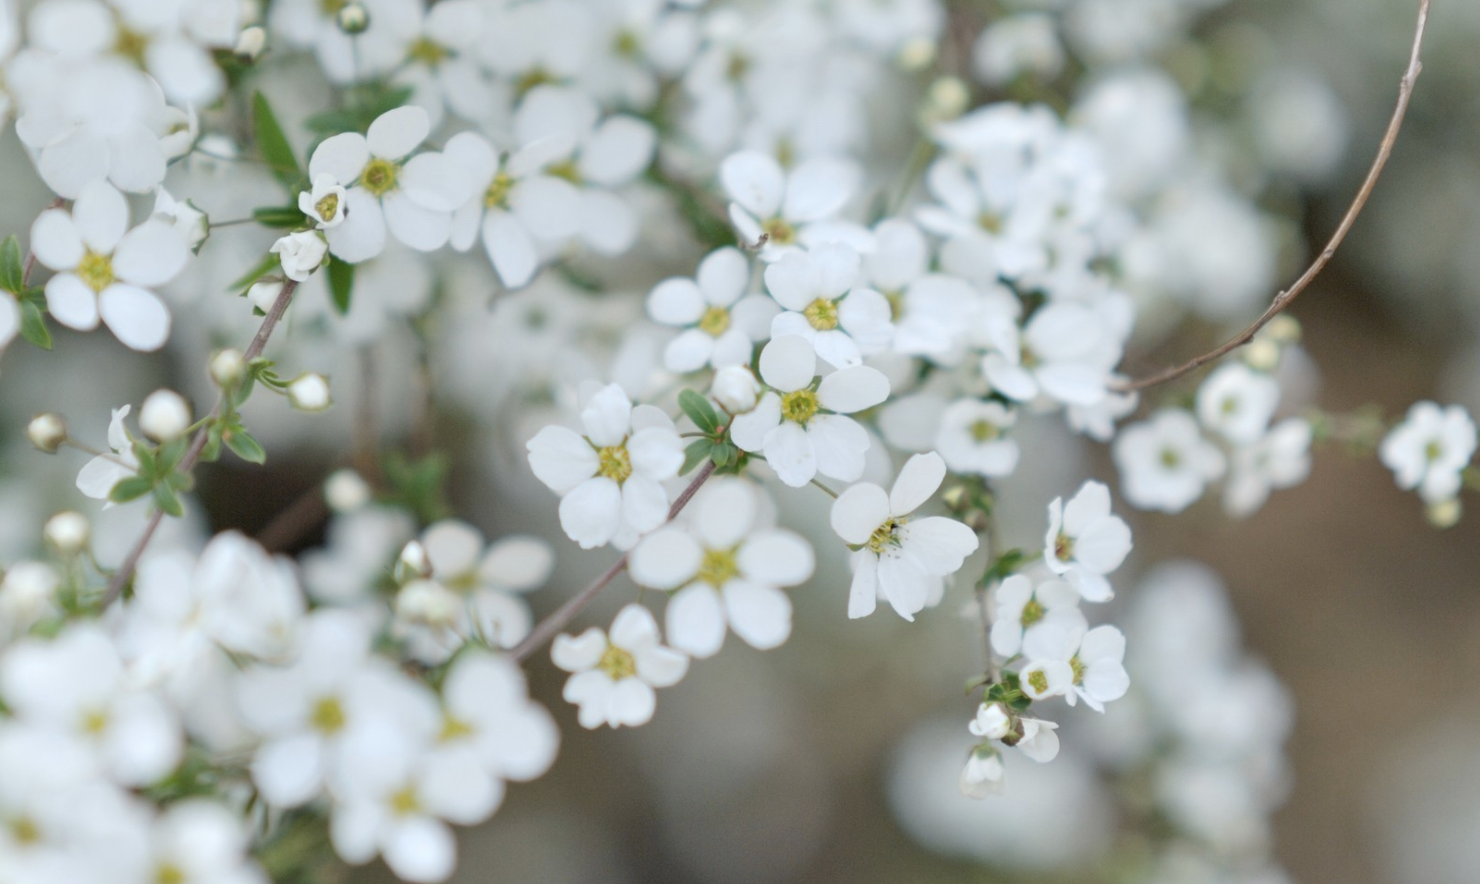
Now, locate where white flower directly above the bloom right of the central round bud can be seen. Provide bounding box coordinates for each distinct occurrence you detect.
[765,243,894,369]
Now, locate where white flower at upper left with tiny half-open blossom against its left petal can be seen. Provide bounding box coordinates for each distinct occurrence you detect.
[308,107,472,264]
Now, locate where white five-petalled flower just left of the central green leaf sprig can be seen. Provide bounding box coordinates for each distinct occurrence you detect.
[525,384,684,549]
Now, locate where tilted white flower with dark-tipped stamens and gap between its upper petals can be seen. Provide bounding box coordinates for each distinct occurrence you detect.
[832,452,980,620]
